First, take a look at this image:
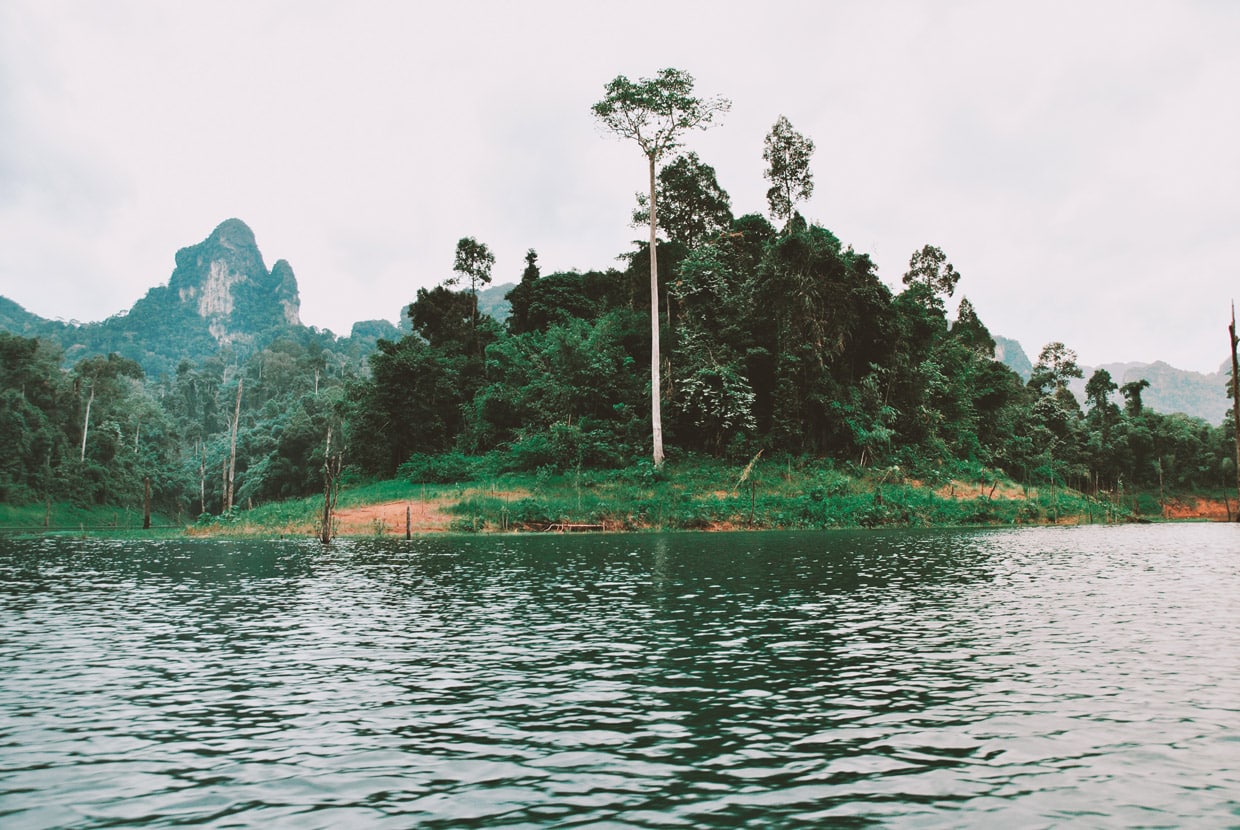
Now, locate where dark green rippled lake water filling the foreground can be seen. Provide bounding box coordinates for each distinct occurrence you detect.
[0,525,1240,829]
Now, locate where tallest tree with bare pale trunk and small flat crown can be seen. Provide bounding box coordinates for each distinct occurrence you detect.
[591,68,732,466]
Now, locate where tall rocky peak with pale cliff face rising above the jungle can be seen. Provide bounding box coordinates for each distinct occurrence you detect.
[167,220,301,346]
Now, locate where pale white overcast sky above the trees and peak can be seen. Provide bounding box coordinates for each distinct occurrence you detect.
[0,0,1240,371]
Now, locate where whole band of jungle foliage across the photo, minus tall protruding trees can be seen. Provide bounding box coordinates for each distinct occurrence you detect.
[0,215,1234,516]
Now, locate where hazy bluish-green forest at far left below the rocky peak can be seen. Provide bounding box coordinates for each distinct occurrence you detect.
[0,330,360,520]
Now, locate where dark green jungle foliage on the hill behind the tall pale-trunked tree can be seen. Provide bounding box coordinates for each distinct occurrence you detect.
[343,215,1234,493]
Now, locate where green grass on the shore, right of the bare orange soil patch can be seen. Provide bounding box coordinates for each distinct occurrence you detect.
[443,459,1130,531]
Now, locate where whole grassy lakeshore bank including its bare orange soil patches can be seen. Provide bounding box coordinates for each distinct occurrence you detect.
[192,459,1162,536]
